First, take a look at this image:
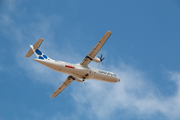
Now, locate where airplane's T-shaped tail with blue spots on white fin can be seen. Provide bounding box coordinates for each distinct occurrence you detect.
[25,38,52,60]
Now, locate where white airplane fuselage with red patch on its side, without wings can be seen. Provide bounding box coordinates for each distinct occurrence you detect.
[35,59,120,83]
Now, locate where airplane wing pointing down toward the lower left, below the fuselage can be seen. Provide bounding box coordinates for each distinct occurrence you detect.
[50,75,74,97]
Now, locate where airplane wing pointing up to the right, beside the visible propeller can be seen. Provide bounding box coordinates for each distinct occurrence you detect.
[80,31,112,67]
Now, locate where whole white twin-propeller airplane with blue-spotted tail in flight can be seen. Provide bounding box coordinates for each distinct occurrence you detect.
[25,31,120,97]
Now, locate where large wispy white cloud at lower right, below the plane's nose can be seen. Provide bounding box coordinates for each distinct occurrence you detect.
[66,63,180,119]
